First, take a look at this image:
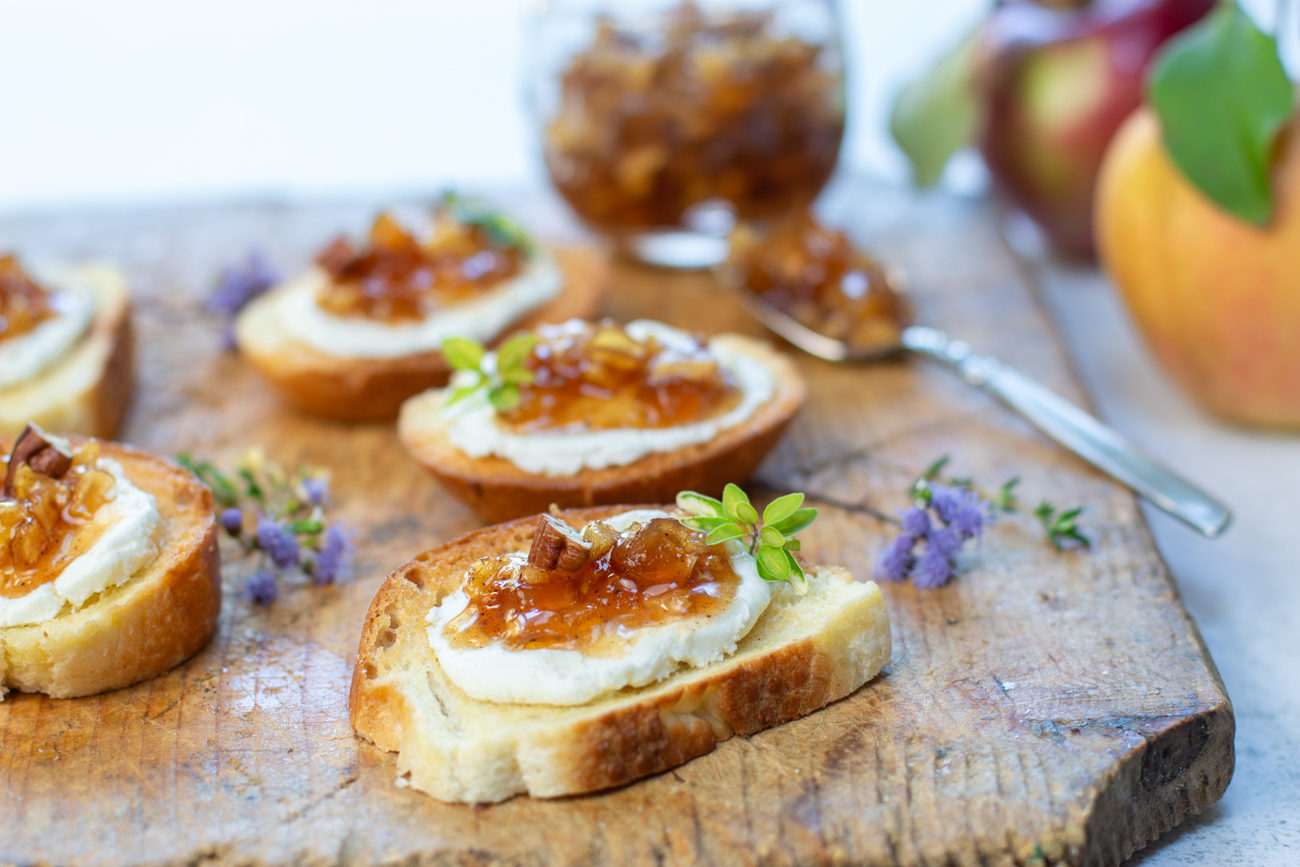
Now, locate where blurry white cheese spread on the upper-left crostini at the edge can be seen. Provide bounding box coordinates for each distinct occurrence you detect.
[0,264,95,390]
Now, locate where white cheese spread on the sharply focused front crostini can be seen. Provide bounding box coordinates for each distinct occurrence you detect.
[428,510,772,705]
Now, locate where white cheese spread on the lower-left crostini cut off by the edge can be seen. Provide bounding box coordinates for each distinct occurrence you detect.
[0,458,161,628]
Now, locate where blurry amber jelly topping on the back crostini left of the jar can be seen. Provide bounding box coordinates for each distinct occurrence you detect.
[316,208,528,322]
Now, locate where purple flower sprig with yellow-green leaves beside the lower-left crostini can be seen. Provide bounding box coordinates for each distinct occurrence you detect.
[179,450,356,604]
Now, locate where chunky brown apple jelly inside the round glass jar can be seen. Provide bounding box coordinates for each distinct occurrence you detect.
[545,3,844,230]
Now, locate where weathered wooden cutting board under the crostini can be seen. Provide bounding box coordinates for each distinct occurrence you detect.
[0,182,1234,864]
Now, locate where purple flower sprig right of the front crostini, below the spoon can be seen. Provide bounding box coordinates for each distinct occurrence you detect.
[874,455,1091,589]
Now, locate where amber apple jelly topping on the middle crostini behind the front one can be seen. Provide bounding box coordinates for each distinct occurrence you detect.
[501,322,742,433]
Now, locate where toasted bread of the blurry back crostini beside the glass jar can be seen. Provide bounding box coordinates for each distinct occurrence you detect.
[235,247,608,421]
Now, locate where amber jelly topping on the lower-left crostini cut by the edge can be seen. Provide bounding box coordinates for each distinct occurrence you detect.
[0,441,117,599]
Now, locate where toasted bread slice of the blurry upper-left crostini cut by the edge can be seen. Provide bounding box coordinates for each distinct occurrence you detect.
[0,265,134,437]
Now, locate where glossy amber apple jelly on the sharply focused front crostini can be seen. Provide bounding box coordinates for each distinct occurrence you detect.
[443,517,740,655]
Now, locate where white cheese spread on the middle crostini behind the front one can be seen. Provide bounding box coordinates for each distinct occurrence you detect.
[441,320,776,476]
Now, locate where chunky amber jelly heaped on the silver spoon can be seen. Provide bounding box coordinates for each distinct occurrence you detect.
[727,212,911,350]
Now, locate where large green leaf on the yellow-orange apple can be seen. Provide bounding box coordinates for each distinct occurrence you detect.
[1148,3,1295,226]
